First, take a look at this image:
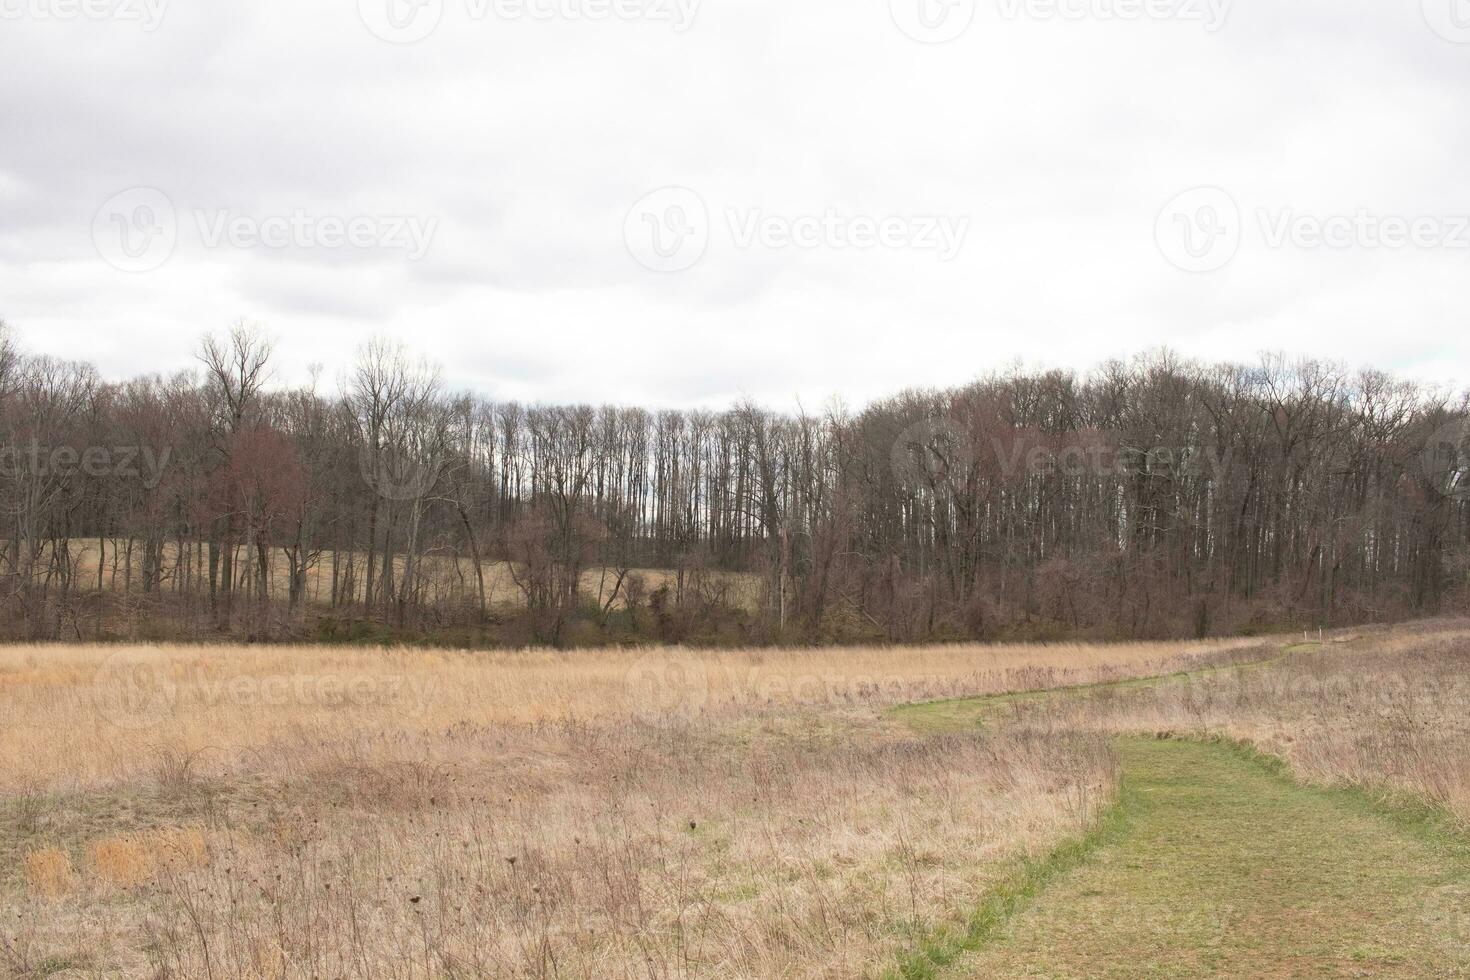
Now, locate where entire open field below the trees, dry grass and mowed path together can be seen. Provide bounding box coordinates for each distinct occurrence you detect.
[0,621,1470,979]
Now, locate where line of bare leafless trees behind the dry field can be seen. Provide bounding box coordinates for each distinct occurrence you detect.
[0,318,1470,645]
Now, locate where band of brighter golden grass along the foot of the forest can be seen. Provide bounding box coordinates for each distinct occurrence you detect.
[0,641,1258,790]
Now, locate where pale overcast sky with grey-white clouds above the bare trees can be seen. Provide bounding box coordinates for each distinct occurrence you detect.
[0,0,1470,406]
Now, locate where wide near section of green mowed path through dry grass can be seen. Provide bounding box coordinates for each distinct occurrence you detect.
[942,739,1470,979]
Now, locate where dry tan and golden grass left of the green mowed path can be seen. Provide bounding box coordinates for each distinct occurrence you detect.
[0,641,1260,977]
